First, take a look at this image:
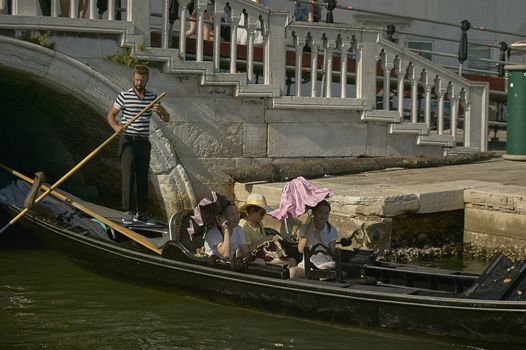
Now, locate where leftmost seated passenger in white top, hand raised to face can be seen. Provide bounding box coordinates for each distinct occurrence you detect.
[205,203,250,259]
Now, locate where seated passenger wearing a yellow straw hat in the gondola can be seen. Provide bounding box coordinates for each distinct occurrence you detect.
[238,193,296,266]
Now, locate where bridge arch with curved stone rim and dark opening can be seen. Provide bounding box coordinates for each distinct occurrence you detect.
[0,36,195,215]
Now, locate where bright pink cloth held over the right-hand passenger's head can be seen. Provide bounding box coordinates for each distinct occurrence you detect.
[268,176,334,220]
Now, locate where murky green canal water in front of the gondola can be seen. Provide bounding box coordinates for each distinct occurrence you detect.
[0,228,503,350]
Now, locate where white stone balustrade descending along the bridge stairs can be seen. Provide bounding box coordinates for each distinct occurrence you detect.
[0,0,488,150]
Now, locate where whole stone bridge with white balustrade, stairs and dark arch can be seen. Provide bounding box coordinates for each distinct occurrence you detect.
[0,0,488,214]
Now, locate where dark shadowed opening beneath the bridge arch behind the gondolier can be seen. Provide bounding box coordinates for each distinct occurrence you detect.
[0,67,127,208]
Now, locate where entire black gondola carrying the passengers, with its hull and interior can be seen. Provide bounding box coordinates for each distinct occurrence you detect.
[0,181,526,348]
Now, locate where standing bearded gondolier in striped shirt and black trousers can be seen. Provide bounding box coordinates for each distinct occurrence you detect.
[107,65,170,225]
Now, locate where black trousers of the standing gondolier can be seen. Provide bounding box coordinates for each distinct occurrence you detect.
[119,134,152,212]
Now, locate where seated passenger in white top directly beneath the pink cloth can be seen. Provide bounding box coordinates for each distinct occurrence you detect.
[291,200,338,278]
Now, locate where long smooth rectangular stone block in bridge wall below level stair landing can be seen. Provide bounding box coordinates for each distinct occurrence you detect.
[268,123,366,157]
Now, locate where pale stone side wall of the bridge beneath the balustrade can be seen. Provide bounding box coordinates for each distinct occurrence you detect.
[0,29,448,215]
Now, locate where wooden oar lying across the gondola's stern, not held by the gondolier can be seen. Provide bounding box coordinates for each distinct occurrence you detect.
[0,163,161,255]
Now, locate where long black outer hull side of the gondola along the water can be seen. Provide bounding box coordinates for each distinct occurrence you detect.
[7,208,526,344]
